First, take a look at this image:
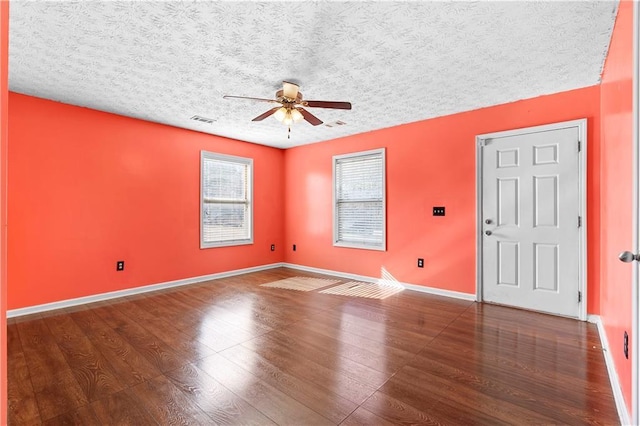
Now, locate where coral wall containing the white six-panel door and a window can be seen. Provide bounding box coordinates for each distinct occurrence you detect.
[285,86,600,313]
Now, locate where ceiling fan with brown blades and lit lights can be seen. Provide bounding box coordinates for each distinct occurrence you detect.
[223,81,351,137]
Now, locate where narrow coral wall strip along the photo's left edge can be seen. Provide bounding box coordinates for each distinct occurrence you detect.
[0,1,9,424]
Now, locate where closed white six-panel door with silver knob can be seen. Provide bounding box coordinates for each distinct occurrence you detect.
[478,120,585,318]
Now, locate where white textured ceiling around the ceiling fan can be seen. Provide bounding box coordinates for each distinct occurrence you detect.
[9,0,617,148]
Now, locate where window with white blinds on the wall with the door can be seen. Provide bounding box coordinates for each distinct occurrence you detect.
[333,149,386,250]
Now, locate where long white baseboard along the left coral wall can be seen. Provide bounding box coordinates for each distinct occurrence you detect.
[7,263,284,318]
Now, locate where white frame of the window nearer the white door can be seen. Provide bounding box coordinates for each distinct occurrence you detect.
[333,148,387,251]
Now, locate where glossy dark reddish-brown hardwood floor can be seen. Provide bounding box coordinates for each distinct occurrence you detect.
[8,269,619,425]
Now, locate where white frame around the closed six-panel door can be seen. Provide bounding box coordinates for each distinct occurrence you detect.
[476,118,587,321]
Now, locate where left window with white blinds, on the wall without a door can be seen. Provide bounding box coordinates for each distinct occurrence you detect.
[200,151,253,248]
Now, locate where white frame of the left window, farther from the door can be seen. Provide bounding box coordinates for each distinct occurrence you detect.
[200,151,253,249]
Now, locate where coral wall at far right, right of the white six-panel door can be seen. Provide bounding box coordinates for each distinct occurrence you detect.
[600,1,633,407]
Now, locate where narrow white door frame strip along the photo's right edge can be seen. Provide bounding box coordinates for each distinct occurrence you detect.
[632,1,640,425]
